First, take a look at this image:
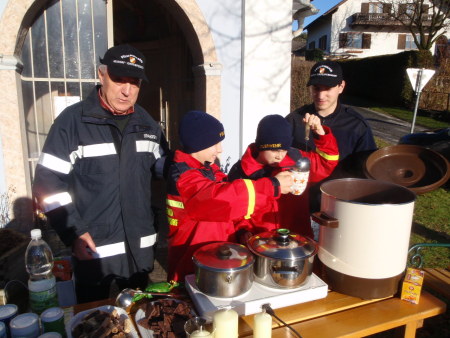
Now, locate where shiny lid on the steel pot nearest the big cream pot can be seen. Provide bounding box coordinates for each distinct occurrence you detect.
[247,229,317,260]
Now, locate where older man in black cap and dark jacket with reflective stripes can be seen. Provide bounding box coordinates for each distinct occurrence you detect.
[33,45,168,302]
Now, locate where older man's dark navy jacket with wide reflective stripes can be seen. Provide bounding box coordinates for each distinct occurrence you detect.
[33,88,168,284]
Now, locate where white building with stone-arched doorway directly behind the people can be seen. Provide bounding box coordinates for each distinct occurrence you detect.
[0,0,312,219]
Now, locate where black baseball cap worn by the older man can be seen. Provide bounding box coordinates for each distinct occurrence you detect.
[100,45,148,82]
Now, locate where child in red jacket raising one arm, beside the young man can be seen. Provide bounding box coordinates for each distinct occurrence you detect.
[228,114,339,242]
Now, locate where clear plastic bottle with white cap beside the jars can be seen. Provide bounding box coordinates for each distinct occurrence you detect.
[25,229,58,314]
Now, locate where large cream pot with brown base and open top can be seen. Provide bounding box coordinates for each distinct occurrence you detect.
[312,178,416,299]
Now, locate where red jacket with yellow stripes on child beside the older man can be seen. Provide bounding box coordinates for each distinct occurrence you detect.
[167,151,279,281]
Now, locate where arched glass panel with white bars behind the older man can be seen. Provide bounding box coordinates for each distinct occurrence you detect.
[21,0,108,180]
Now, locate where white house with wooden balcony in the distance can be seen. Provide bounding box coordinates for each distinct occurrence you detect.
[305,0,448,58]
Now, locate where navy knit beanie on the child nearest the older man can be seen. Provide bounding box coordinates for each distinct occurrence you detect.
[178,110,225,154]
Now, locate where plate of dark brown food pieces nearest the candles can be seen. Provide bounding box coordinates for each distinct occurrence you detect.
[134,298,196,338]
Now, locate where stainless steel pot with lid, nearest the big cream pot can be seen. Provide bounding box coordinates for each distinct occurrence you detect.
[247,229,317,289]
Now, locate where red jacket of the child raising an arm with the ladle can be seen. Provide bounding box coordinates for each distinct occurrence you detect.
[228,126,339,237]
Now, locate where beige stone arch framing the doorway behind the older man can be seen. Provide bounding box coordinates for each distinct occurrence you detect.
[0,0,221,197]
